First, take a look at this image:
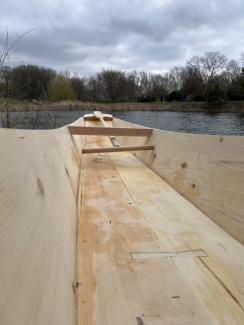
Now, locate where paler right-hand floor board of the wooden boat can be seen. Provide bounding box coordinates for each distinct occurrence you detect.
[109,154,244,324]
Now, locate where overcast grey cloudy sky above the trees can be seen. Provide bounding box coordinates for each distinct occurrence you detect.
[0,0,244,75]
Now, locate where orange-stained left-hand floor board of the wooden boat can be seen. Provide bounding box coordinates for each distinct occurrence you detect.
[77,137,213,325]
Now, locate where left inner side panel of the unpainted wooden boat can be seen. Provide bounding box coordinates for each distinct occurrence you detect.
[0,122,82,325]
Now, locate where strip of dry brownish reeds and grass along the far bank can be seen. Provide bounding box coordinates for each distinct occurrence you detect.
[0,101,244,113]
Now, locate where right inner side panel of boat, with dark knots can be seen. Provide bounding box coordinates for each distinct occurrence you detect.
[113,119,244,244]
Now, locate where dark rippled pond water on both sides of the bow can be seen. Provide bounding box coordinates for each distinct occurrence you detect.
[0,111,244,135]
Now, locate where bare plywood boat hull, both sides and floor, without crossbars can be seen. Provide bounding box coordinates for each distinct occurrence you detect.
[0,114,244,325]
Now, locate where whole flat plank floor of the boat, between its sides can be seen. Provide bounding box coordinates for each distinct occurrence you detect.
[76,130,244,325]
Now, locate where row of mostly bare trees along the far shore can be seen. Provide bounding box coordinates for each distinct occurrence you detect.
[0,52,244,103]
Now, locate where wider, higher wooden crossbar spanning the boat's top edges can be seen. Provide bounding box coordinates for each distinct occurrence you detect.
[68,126,153,137]
